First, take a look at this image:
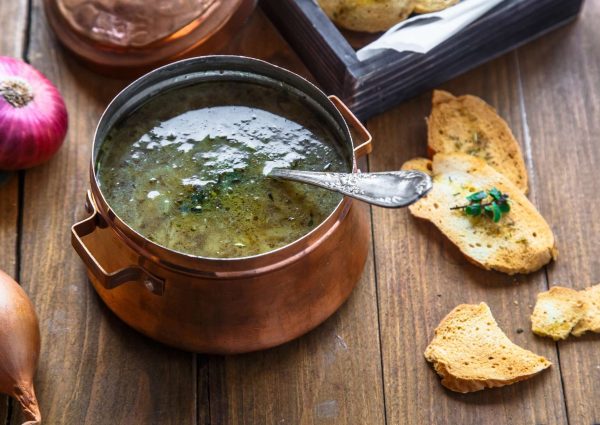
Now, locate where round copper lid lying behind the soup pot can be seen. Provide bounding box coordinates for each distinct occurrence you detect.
[44,0,256,76]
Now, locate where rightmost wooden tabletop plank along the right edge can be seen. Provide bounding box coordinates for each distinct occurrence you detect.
[518,1,600,425]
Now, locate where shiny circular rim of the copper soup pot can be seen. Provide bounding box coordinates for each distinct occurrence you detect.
[90,55,370,278]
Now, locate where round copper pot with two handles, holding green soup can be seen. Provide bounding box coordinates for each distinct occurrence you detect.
[72,56,371,353]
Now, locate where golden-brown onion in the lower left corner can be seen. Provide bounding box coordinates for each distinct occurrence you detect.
[0,270,41,425]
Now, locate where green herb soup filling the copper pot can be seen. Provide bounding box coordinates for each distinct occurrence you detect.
[97,82,350,257]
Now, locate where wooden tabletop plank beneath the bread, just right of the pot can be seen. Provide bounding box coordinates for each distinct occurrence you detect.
[369,55,566,424]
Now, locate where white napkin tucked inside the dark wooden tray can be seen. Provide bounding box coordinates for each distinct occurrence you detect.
[356,0,505,61]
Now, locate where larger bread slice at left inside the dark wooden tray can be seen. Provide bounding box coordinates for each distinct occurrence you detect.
[317,0,415,32]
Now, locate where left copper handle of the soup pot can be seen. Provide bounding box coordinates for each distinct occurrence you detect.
[71,191,165,295]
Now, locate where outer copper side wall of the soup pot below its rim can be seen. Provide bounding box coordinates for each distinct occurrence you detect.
[78,189,370,354]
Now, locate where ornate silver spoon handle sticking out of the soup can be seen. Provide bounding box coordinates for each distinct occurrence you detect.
[267,168,432,208]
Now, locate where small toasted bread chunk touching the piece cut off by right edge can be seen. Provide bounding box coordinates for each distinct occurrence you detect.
[531,286,586,341]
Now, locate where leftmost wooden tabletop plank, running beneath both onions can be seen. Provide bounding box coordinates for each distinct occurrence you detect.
[0,0,28,423]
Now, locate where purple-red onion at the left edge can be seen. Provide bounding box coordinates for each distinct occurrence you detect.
[0,56,68,170]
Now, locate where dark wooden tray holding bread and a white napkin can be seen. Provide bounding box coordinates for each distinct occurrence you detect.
[261,0,582,119]
